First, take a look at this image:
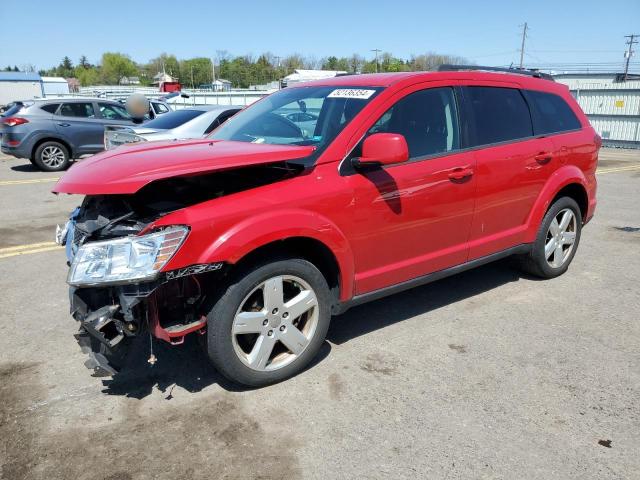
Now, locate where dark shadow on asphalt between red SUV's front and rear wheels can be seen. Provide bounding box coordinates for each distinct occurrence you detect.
[327,259,536,345]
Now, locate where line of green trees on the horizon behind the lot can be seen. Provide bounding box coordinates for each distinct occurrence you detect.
[35,50,469,88]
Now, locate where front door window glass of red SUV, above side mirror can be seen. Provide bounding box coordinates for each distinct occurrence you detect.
[368,87,460,159]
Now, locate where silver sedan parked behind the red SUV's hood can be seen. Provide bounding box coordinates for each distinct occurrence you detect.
[104,105,242,150]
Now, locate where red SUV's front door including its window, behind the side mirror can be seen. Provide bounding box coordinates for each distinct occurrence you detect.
[347,85,475,294]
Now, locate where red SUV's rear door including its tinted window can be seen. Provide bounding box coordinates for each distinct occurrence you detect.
[463,86,556,260]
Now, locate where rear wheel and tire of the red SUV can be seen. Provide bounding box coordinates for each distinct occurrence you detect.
[516,197,582,278]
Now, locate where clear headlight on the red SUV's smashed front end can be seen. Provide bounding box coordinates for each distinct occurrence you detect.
[67,227,189,286]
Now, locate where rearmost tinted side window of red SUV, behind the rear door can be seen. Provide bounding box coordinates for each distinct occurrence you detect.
[524,90,582,135]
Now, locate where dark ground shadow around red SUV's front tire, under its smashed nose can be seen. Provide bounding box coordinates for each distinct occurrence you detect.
[102,335,331,400]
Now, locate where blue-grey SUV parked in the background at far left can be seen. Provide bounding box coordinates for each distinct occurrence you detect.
[0,97,169,172]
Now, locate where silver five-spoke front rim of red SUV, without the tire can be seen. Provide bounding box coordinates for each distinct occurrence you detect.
[231,275,319,371]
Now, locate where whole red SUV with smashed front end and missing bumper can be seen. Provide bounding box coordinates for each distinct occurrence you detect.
[53,69,601,386]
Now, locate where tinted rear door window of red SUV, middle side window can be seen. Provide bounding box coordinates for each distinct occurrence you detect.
[465,87,533,146]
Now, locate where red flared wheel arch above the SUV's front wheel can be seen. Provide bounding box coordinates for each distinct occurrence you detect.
[198,209,354,300]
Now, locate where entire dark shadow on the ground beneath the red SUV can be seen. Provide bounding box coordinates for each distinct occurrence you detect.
[103,260,534,400]
